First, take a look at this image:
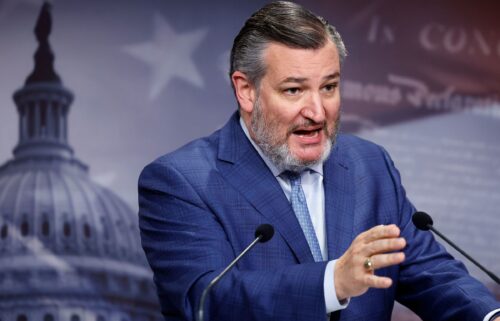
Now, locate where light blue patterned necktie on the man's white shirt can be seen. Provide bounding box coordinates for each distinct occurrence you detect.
[283,171,323,262]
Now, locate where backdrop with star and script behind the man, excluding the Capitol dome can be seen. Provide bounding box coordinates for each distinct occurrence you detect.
[0,0,500,320]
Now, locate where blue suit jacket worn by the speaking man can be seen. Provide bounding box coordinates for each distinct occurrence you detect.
[139,113,499,321]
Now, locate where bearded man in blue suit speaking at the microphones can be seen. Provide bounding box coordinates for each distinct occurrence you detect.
[139,2,500,321]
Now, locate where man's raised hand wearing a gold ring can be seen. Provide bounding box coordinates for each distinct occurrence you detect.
[334,224,406,300]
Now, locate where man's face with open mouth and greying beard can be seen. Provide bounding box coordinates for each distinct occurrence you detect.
[247,41,340,171]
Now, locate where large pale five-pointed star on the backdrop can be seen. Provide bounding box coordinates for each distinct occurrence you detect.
[123,14,208,100]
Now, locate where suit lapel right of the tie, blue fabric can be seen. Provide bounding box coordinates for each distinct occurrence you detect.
[323,136,355,260]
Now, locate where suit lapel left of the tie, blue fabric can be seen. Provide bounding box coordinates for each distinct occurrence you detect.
[218,113,314,263]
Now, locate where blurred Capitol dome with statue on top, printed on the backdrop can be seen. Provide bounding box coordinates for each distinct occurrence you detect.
[0,3,161,321]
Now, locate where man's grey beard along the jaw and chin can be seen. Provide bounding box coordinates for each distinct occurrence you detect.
[251,98,340,173]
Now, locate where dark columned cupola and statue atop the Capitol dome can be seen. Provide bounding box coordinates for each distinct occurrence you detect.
[14,2,73,159]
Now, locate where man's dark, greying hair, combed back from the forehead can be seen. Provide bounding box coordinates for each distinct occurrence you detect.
[229,1,347,90]
